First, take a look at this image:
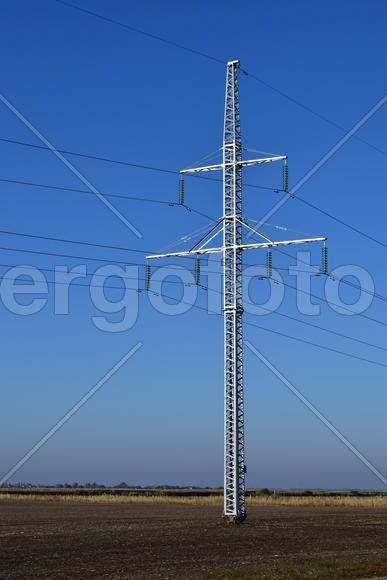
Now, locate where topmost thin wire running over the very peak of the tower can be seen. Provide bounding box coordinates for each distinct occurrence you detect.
[56,0,387,156]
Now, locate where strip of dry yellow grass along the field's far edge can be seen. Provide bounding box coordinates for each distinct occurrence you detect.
[0,493,387,508]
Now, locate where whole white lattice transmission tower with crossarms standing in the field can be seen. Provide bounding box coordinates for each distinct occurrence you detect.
[146,60,326,523]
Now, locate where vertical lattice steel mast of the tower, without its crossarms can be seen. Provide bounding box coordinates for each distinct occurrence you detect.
[223,61,246,520]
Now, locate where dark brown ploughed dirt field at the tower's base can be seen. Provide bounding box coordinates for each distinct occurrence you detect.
[0,500,387,580]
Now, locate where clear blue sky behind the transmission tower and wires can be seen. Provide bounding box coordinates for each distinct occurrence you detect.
[0,0,387,488]
